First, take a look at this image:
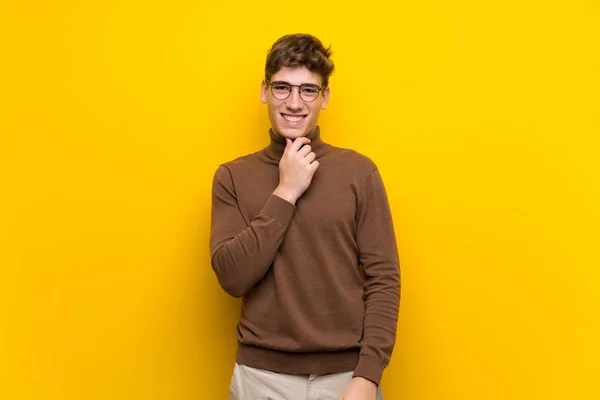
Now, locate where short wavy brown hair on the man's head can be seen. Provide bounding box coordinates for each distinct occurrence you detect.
[265,34,335,86]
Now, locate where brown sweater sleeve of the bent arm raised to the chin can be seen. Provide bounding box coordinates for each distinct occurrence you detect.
[210,165,296,297]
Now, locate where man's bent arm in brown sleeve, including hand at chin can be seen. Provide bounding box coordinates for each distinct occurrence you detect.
[210,137,319,297]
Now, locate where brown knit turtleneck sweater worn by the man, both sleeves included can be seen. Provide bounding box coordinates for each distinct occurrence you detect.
[210,127,400,384]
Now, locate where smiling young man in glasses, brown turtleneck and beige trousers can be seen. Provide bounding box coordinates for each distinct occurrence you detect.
[210,35,400,400]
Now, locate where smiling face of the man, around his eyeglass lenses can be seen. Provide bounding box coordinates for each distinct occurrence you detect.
[261,67,329,140]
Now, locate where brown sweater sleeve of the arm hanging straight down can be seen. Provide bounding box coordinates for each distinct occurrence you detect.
[354,169,400,384]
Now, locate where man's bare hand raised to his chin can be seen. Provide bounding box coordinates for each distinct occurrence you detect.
[273,137,319,204]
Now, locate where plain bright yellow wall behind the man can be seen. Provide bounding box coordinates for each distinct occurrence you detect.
[0,0,600,400]
